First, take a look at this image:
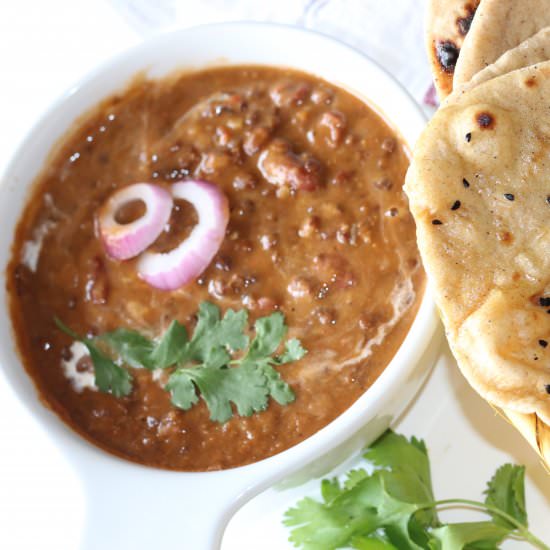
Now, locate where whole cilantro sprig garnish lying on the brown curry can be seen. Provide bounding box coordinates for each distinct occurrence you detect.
[55,302,306,423]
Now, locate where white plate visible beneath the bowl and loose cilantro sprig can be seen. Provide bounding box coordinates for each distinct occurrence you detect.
[222,343,550,550]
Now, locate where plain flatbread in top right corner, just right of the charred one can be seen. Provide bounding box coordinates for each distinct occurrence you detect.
[453,0,550,88]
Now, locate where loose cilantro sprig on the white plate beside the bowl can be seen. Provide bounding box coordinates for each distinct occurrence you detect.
[284,431,550,550]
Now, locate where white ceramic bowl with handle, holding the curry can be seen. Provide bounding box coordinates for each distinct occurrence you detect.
[0,23,438,550]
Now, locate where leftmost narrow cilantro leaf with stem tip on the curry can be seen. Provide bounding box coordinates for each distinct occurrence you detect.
[54,318,132,397]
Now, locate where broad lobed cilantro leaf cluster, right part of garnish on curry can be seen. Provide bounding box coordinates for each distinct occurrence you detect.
[166,303,305,422]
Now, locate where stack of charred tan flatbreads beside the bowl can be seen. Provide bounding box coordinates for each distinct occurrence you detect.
[414,0,550,466]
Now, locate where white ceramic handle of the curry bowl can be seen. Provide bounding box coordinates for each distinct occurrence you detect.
[77,457,273,550]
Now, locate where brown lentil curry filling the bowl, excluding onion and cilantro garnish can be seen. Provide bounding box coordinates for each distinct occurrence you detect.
[8,63,424,471]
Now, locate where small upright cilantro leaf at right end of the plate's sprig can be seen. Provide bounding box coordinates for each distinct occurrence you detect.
[485,464,527,529]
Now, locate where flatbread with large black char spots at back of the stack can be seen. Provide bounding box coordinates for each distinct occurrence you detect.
[426,0,479,100]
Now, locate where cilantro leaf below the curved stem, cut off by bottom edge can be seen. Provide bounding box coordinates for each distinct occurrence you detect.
[431,521,510,550]
